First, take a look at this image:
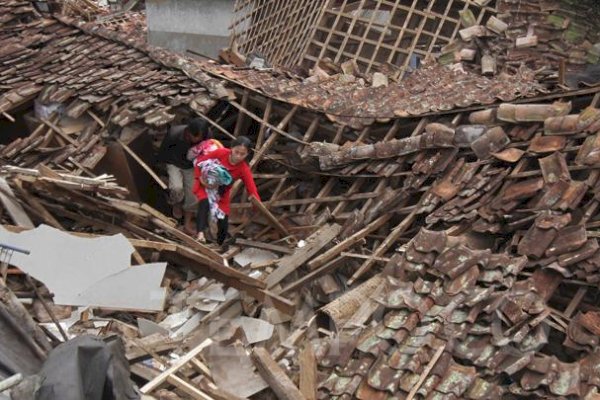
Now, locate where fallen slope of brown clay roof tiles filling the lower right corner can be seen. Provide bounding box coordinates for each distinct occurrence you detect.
[316,230,600,400]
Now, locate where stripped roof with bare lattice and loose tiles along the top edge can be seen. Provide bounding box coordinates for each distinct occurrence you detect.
[231,0,598,78]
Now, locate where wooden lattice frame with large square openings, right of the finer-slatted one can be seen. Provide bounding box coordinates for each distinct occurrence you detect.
[302,0,496,77]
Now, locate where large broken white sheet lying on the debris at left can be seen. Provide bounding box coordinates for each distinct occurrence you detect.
[0,225,167,311]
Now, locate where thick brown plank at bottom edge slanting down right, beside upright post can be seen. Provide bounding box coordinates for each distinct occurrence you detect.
[252,347,305,400]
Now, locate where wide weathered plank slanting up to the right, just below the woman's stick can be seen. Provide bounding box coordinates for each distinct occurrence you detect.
[266,224,342,288]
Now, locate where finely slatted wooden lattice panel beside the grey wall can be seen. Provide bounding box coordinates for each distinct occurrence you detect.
[229,0,327,67]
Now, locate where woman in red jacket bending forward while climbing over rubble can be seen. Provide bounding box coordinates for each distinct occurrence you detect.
[194,136,260,245]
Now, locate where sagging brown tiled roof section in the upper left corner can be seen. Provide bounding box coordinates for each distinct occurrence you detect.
[0,0,223,126]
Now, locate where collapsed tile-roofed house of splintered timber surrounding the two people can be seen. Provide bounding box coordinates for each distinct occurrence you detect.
[0,0,600,399]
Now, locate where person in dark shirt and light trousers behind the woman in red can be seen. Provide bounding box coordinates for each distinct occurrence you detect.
[157,119,210,235]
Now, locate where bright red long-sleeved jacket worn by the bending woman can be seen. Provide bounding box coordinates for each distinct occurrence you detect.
[193,148,260,215]
